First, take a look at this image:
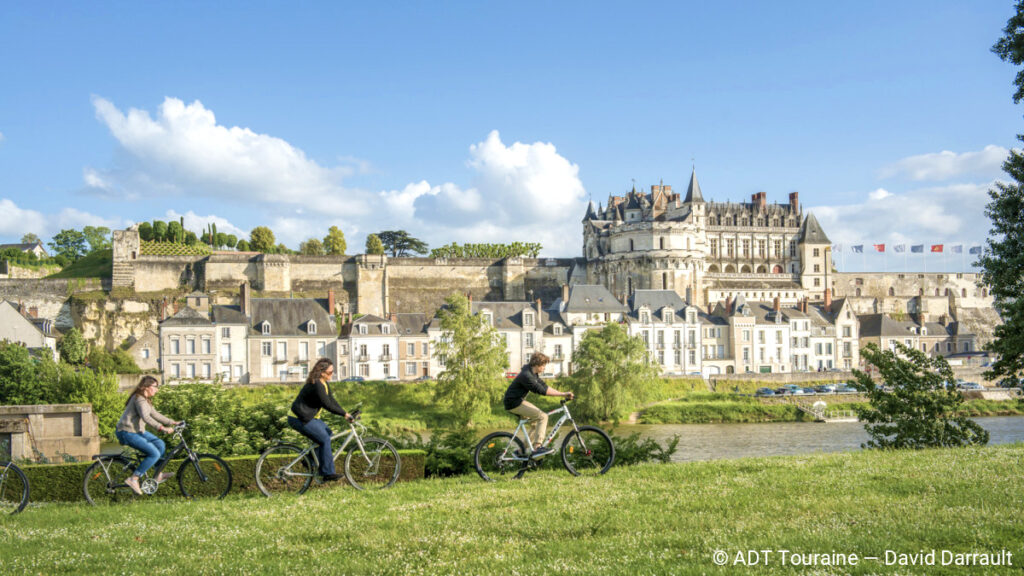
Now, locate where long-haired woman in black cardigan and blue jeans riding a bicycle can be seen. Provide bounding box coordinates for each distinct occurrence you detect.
[288,358,352,482]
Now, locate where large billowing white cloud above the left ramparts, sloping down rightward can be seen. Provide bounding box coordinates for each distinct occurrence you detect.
[85,97,367,212]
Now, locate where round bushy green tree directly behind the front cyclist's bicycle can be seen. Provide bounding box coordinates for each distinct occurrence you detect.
[568,323,658,420]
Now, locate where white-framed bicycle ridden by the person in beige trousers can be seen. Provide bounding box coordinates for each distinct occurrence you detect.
[473,399,615,482]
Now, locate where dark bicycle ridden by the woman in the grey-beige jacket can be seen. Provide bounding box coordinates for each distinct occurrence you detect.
[82,422,231,505]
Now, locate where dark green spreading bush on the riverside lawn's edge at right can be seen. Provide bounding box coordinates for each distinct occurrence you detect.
[853,343,988,449]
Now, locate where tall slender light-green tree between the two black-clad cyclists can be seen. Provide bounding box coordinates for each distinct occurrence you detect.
[434,294,509,427]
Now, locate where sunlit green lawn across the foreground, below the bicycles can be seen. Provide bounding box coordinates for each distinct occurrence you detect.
[0,444,1024,575]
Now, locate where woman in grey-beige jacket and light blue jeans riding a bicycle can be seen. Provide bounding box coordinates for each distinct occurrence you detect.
[114,375,180,494]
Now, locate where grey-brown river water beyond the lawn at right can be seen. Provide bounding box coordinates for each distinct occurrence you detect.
[614,416,1024,462]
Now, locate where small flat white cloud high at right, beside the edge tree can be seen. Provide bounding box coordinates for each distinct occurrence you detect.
[879,145,1010,181]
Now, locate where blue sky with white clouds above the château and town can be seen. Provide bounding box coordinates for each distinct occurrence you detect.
[0,1,1024,270]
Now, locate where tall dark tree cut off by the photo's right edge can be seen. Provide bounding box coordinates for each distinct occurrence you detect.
[976,0,1024,386]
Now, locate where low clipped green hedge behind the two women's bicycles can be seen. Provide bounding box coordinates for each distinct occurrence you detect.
[18,450,427,502]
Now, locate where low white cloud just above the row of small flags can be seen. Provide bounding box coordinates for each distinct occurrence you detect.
[808,182,993,247]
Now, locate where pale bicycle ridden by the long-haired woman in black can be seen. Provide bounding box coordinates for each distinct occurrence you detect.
[256,405,401,497]
